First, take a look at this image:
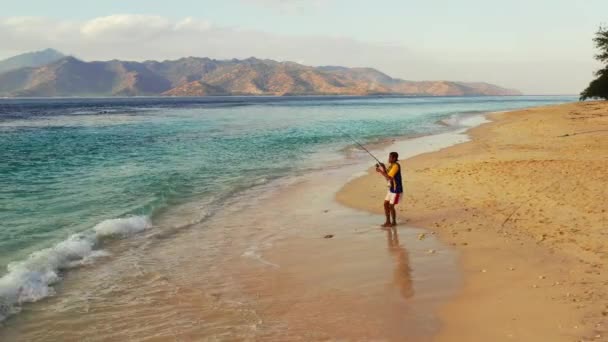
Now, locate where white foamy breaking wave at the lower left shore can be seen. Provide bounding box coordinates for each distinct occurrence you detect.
[0,216,152,321]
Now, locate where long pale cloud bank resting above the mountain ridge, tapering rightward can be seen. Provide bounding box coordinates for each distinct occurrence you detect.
[0,14,422,66]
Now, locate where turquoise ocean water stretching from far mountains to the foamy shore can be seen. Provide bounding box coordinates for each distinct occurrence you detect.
[0,96,576,321]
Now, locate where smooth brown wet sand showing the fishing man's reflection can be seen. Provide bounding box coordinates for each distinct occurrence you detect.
[232,166,461,341]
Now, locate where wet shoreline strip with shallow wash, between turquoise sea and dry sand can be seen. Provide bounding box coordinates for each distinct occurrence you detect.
[0,146,461,341]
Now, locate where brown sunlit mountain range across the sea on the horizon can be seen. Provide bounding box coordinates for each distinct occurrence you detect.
[0,49,520,97]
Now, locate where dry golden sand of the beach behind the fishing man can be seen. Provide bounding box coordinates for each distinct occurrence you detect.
[337,102,608,341]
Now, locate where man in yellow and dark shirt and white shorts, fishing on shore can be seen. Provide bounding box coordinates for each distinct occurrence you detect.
[376,152,403,227]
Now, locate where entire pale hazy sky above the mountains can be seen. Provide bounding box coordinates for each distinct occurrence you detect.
[0,0,608,94]
